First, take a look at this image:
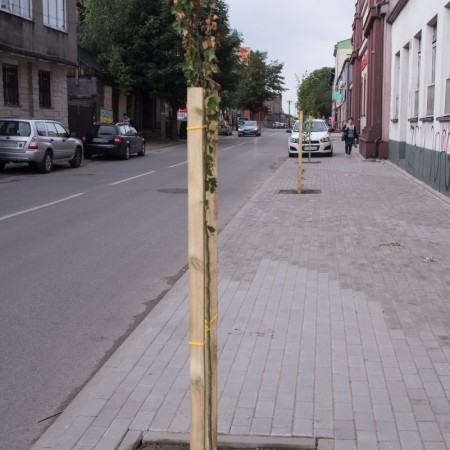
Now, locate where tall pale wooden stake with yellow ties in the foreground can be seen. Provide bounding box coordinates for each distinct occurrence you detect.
[187,87,207,450]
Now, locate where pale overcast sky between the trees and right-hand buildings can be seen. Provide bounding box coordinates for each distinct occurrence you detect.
[225,0,356,113]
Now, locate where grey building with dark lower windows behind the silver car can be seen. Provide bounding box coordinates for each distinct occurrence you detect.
[0,0,77,126]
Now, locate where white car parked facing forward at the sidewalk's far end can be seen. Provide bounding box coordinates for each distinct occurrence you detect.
[288,119,333,157]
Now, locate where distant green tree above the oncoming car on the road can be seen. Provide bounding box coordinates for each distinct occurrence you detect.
[238,51,285,113]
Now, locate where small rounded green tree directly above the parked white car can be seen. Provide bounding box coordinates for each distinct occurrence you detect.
[297,67,332,117]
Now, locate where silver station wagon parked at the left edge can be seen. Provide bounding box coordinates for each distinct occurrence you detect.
[0,118,83,173]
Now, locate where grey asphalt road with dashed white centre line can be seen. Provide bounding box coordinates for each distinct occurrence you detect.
[0,130,288,450]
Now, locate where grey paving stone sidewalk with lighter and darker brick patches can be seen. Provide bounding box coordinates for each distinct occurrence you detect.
[33,141,450,450]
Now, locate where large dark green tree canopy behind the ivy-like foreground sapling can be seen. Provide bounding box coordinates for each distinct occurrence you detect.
[78,0,242,117]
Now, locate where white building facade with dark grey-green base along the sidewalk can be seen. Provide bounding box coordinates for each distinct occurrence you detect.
[388,0,450,196]
